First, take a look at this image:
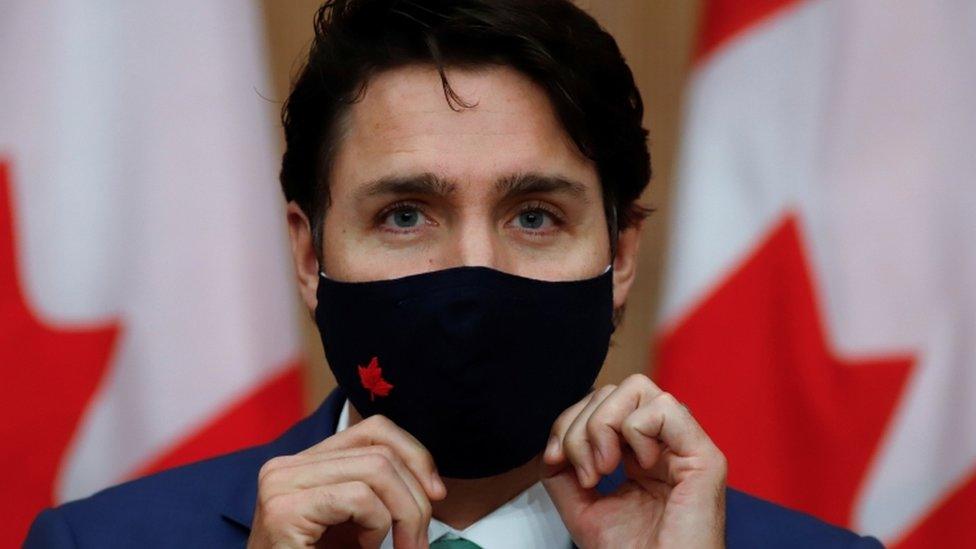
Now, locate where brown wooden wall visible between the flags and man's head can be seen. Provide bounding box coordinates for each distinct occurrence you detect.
[263,0,698,408]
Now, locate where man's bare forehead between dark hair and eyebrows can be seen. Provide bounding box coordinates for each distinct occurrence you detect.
[331,65,598,196]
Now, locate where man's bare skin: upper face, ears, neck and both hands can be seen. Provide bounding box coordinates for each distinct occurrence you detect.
[249,66,727,548]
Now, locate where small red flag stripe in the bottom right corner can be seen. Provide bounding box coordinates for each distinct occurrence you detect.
[891,471,976,549]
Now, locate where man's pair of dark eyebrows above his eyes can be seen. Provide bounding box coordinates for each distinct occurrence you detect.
[356,172,586,201]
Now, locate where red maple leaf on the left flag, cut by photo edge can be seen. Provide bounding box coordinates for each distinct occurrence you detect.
[0,161,119,547]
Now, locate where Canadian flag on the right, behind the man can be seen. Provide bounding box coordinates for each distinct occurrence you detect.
[656,0,976,548]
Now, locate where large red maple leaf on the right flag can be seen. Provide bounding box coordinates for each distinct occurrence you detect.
[656,216,914,526]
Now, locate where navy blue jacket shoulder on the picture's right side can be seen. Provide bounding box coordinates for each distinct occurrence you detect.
[725,488,883,549]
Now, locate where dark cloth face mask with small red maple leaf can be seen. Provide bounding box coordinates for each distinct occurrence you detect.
[315,267,613,478]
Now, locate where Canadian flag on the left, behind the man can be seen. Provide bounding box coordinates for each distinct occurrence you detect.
[0,0,302,547]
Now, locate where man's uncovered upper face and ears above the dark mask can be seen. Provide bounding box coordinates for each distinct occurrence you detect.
[289,66,636,309]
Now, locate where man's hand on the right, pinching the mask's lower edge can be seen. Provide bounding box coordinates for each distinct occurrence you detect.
[543,375,727,549]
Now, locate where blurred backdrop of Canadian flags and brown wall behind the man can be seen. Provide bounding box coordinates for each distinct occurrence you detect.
[0,0,976,548]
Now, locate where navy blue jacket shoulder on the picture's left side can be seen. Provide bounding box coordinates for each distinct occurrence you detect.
[24,391,345,549]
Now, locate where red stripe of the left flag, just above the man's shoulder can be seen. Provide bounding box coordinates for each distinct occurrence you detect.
[133,360,304,477]
